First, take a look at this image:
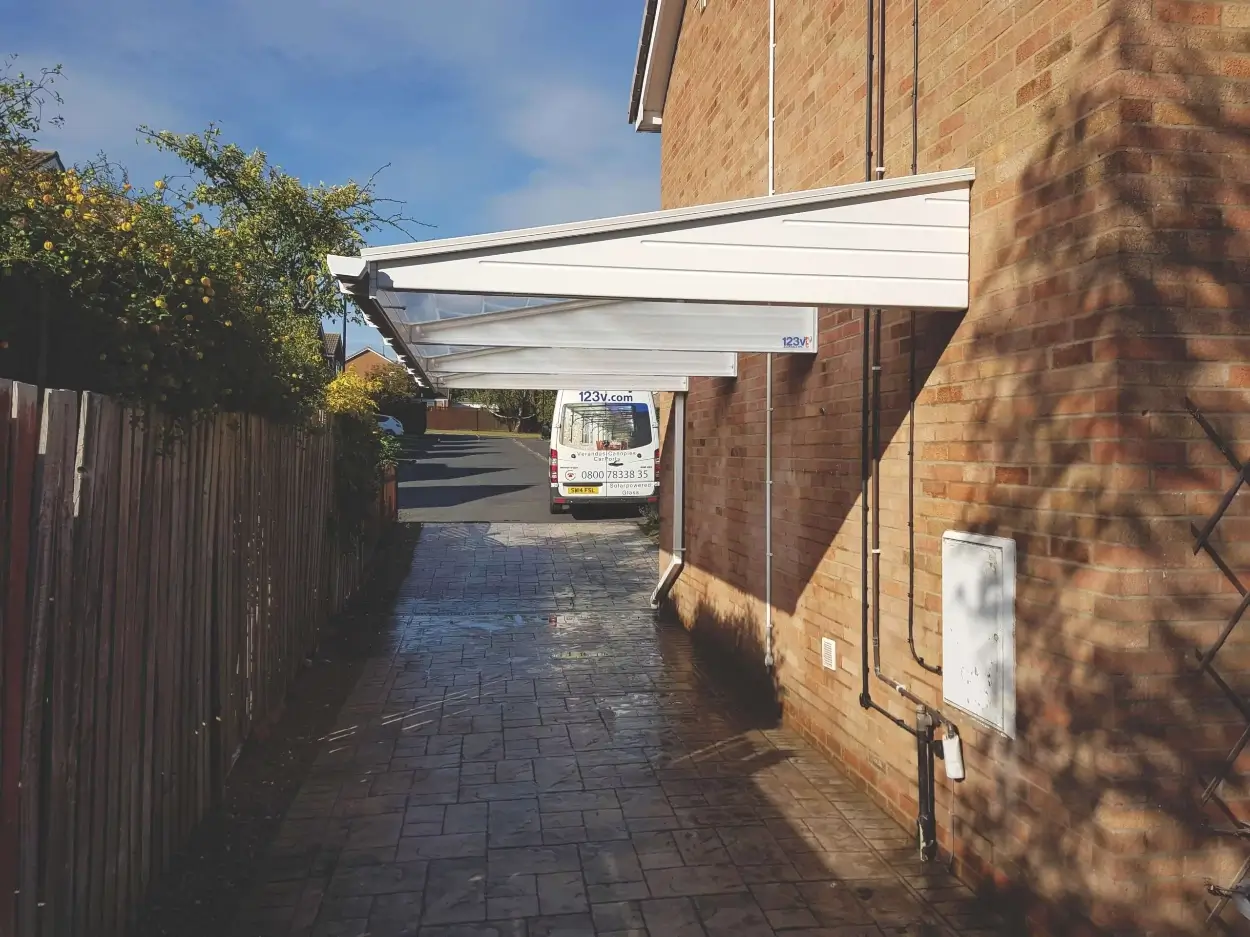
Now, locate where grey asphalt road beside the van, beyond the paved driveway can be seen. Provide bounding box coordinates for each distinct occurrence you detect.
[399,434,638,523]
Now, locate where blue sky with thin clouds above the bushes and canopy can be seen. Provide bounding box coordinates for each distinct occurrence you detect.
[9,0,659,351]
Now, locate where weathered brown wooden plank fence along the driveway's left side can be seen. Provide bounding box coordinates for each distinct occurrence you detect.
[0,380,395,937]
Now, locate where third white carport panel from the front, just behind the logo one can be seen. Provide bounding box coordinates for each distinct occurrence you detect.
[424,349,738,380]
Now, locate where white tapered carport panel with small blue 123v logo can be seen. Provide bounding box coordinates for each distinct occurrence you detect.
[406,300,818,352]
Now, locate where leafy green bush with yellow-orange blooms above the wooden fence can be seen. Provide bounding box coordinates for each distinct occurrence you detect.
[0,60,415,420]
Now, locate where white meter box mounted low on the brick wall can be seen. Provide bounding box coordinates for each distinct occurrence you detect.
[941,531,1016,738]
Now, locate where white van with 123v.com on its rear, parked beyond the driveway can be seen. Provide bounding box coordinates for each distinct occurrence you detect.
[551,390,660,513]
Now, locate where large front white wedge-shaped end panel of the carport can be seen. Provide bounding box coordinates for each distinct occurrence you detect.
[361,170,974,310]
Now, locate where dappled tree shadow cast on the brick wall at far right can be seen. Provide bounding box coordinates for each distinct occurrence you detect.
[939,0,1250,936]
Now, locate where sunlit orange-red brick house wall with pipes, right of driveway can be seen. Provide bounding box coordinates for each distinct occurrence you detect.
[663,0,1250,933]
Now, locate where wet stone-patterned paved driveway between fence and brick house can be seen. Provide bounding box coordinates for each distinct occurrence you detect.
[234,522,998,937]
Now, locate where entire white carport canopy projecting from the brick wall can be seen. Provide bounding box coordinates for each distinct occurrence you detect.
[329,170,974,390]
